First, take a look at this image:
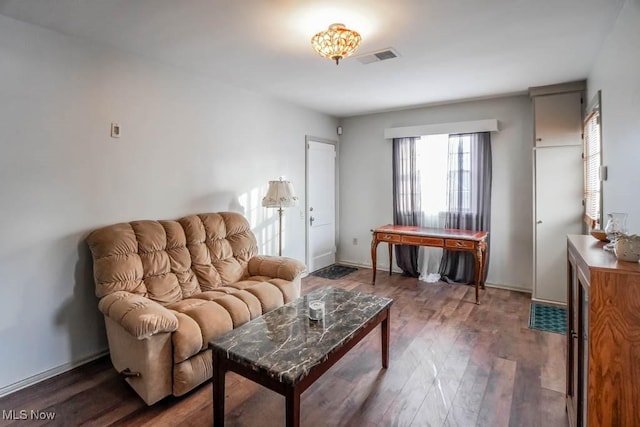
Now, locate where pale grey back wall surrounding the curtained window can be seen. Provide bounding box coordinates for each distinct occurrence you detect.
[338,96,533,290]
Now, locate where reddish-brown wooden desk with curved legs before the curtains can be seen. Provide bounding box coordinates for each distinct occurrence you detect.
[371,224,489,304]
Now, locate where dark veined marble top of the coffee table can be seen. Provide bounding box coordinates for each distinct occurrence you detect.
[209,287,393,384]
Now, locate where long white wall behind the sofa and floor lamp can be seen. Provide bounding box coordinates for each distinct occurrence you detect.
[0,15,337,394]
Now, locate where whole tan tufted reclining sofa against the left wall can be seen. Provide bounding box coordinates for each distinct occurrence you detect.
[87,212,305,405]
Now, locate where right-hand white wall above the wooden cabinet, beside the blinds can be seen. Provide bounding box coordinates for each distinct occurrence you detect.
[587,0,640,234]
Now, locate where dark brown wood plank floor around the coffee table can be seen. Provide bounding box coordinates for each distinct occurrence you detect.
[0,269,568,427]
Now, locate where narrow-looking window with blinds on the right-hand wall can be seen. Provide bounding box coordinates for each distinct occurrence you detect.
[582,92,602,228]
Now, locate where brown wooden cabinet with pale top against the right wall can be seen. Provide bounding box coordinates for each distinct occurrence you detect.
[566,235,640,427]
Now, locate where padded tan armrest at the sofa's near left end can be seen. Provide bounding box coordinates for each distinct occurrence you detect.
[98,291,178,340]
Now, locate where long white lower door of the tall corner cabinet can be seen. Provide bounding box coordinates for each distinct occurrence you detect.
[533,146,583,303]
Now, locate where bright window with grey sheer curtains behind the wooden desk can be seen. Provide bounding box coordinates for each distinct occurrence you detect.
[393,132,491,282]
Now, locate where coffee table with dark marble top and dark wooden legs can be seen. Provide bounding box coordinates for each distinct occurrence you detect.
[209,287,393,427]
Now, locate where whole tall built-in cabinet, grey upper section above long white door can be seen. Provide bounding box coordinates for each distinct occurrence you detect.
[529,82,585,304]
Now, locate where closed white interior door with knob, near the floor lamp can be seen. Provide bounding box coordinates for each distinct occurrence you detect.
[306,138,336,271]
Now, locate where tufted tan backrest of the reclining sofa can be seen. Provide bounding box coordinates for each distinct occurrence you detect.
[87,212,257,305]
